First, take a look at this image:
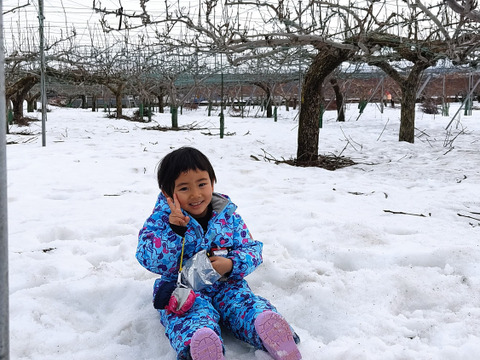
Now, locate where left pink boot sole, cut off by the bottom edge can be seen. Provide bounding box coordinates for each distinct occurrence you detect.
[190,327,225,360]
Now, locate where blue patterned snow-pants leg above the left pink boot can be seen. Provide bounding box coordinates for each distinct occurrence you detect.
[159,296,223,360]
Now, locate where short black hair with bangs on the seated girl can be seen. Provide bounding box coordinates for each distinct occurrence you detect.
[157,146,217,197]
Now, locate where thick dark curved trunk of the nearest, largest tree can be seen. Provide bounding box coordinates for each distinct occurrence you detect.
[297,48,351,162]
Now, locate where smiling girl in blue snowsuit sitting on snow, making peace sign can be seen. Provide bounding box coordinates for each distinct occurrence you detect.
[136,147,301,360]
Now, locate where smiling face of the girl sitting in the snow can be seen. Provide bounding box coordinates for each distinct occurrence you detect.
[173,170,213,218]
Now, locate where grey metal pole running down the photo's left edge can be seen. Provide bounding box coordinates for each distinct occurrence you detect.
[0,0,10,360]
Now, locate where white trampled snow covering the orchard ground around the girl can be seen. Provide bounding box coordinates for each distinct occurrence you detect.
[7,104,480,360]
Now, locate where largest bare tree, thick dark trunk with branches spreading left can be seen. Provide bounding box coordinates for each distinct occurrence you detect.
[96,0,369,161]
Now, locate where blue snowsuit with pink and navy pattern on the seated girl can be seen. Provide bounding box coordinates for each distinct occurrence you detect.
[136,193,277,360]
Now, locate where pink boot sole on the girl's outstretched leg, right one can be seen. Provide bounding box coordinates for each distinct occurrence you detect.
[255,311,302,360]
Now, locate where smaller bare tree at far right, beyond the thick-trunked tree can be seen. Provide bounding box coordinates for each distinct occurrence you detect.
[356,0,480,143]
